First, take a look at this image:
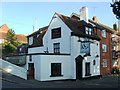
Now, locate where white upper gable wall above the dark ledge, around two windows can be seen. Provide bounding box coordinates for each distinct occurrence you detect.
[43,16,71,54]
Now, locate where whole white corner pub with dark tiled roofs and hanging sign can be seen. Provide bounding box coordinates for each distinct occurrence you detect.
[24,13,100,81]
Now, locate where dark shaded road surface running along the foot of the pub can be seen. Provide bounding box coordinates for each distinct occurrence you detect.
[0,71,120,89]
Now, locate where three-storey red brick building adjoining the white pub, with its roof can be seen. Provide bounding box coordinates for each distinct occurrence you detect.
[89,16,114,75]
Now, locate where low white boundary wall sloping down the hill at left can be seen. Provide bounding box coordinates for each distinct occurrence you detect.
[0,59,27,79]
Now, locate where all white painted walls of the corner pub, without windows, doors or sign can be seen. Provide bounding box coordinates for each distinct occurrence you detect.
[25,12,100,81]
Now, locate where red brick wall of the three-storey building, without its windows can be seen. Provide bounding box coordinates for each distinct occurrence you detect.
[97,29,112,75]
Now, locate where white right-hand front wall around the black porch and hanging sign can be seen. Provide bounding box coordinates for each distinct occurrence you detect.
[71,36,100,78]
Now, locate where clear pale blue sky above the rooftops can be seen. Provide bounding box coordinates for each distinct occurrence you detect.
[0,2,117,35]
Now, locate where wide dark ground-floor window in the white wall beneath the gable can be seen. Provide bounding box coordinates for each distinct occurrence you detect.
[51,63,62,77]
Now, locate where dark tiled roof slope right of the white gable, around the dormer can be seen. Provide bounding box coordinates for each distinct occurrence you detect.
[56,13,100,40]
